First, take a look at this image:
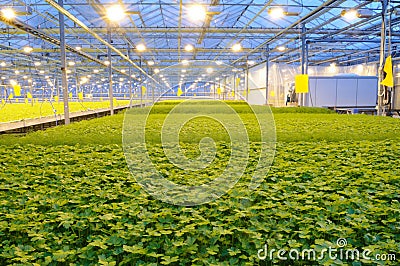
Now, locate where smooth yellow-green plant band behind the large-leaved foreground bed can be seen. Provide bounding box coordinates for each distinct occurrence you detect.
[0,104,400,145]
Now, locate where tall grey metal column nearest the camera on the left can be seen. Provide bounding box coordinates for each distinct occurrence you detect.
[57,0,70,125]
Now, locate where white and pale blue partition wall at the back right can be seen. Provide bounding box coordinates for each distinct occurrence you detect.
[244,63,378,106]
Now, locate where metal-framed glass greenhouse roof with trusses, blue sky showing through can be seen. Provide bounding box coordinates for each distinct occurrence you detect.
[0,0,400,117]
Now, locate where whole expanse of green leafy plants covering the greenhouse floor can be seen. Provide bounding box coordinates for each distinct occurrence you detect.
[0,101,400,265]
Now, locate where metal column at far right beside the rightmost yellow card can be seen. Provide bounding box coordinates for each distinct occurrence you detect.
[377,0,388,115]
